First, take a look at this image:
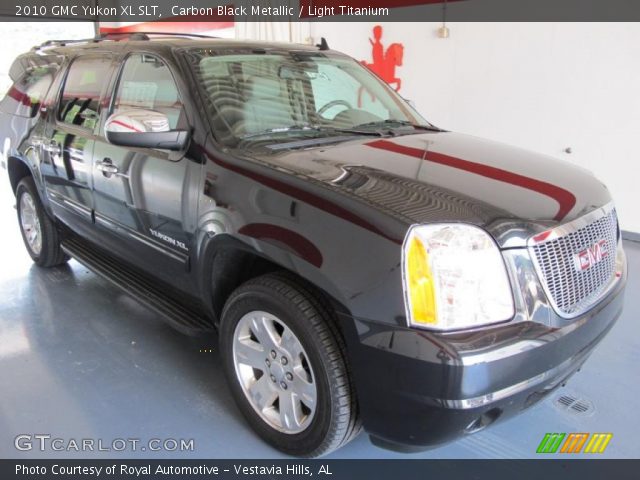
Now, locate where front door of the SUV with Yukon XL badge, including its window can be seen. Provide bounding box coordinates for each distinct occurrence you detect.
[92,52,195,290]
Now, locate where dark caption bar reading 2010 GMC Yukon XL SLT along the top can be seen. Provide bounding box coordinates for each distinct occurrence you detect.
[0,0,640,23]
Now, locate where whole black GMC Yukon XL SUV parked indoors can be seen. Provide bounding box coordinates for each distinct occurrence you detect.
[0,34,626,456]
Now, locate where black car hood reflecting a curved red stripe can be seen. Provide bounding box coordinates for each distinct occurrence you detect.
[245,132,611,246]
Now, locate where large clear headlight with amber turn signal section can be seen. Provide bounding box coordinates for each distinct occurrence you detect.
[402,223,514,330]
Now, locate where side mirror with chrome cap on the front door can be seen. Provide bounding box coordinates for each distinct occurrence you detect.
[104,108,189,150]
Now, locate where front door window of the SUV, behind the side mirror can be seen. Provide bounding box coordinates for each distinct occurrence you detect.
[114,54,182,129]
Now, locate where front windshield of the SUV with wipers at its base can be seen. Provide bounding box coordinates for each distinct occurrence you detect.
[189,49,429,146]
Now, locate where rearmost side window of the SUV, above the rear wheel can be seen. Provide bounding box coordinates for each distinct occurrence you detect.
[1,67,58,117]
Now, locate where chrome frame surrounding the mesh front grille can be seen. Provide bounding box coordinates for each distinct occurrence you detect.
[527,202,619,320]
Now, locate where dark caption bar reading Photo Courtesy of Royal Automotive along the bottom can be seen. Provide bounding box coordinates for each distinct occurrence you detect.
[0,459,640,480]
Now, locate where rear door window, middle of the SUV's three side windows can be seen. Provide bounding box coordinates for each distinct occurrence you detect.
[58,57,111,130]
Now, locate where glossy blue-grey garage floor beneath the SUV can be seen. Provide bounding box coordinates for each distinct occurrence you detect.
[0,185,640,458]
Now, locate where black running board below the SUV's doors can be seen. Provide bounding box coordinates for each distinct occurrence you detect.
[61,236,215,335]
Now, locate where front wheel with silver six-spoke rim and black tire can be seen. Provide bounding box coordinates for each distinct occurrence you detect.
[220,273,361,457]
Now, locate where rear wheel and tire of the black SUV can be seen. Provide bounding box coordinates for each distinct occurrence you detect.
[16,177,69,267]
